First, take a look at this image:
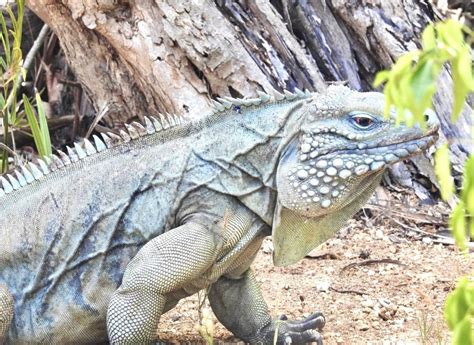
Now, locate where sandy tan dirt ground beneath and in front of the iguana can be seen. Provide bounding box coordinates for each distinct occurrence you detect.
[158,187,474,345]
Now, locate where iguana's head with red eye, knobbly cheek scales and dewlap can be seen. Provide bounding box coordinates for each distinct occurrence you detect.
[273,86,439,266]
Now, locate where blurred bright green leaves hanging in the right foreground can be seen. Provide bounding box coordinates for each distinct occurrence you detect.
[374,20,474,345]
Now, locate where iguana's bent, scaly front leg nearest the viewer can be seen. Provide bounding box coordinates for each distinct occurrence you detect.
[107,222,218,345]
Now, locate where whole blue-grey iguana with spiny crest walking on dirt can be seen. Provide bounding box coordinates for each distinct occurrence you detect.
[0,86,439,344]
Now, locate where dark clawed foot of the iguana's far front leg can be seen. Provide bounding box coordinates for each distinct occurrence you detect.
[252,313,326,345]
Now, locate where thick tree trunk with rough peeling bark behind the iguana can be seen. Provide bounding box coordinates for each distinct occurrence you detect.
[28,0,473,179]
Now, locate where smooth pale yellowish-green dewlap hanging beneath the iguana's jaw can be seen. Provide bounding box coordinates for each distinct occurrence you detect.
[272,171,383,266]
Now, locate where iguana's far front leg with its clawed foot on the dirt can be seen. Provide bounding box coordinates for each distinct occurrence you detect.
[209,269,325,344]
